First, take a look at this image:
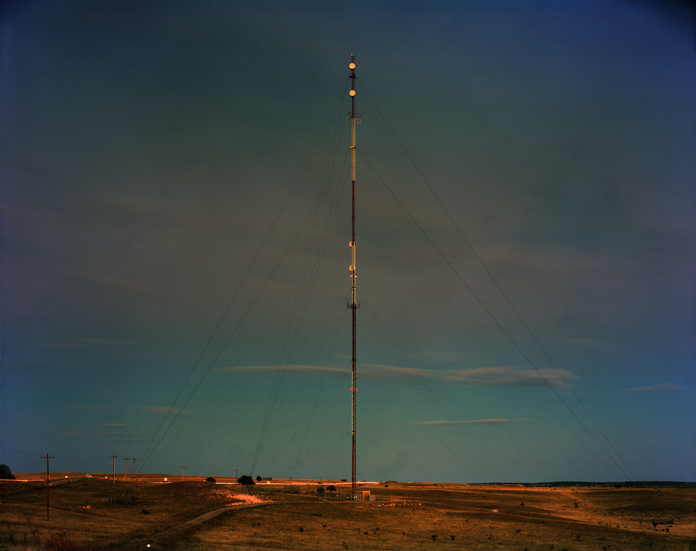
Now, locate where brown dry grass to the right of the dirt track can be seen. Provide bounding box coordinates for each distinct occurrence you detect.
[185,484,696,551]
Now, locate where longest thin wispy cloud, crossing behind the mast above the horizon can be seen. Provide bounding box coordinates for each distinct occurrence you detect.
[218,364,578,388]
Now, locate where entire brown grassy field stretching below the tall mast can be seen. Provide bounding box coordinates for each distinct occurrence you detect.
[0,474,696,551]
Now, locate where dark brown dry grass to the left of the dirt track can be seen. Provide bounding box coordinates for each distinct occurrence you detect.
[0,478,245,549]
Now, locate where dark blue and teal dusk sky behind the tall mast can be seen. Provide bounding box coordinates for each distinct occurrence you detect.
[0,0,696,482]
